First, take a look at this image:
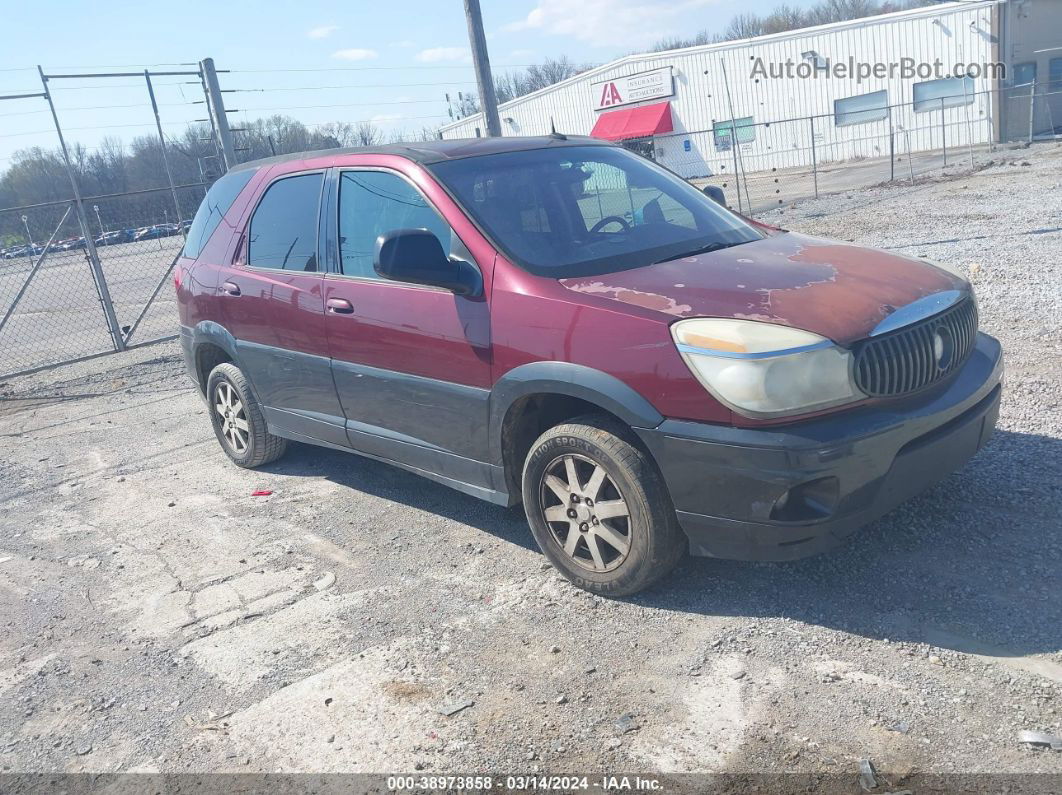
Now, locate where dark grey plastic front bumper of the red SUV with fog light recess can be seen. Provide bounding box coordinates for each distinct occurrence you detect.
[637,333,1004,560]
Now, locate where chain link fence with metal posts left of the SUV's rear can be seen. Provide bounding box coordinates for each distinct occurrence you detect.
[0,184,206,375]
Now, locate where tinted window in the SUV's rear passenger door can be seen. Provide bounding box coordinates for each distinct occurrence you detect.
[247,173,324,271]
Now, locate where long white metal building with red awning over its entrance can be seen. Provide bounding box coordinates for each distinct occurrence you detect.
[440,0,1062,177]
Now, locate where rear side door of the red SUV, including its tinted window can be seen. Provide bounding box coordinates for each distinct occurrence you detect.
[218,170,346,446]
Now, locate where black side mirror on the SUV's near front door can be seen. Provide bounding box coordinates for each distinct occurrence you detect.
[373,229,482,295]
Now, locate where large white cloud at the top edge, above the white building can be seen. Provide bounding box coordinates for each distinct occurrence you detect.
[502,0,719,47]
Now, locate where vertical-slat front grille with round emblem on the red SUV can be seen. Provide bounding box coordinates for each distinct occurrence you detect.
[855,298,977,397]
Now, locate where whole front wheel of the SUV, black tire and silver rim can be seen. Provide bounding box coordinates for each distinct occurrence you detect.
[521,415,687,597]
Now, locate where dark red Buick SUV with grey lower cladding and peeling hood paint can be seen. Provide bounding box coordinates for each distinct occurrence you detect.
[175,135,1003,595]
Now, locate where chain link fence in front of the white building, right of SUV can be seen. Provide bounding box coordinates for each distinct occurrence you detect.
[649,82,1062,215]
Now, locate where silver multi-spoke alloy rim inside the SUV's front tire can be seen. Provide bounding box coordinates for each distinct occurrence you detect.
[541,453,631,573]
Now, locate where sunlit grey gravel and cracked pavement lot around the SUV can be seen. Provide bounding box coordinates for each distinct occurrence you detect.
[0,145,1062,792]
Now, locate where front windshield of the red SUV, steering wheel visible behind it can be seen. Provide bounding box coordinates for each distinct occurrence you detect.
[431,145,764,279]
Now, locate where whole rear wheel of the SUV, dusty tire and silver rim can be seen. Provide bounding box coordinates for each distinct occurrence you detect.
[206,362,288,469]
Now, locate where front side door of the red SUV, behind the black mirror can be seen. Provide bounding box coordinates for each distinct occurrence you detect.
[324,169,493,487]
